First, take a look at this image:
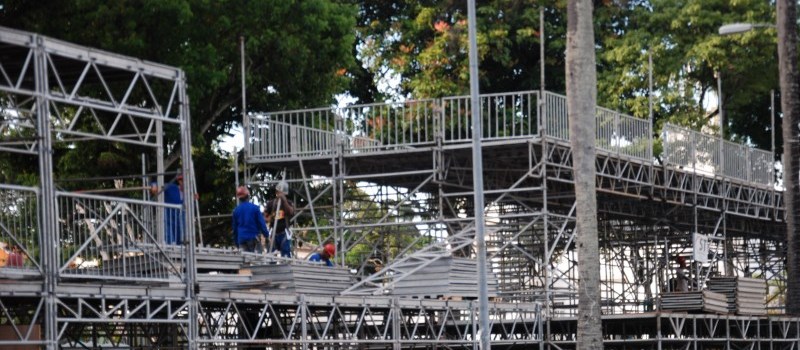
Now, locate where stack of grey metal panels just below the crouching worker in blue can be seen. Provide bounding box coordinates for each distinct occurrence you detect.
[250,263,355,295]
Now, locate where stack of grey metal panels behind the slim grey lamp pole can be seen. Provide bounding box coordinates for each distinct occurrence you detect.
[391,257,498,298]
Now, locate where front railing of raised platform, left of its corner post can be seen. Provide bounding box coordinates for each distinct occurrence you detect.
[248,91,539,159]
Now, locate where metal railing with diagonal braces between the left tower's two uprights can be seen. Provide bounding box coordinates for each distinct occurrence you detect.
[56,192,185,281]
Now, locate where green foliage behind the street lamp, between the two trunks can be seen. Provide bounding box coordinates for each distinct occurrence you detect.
[595,0,777,148]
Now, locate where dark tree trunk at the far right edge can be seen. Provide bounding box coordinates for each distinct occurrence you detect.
[777,0,800,315]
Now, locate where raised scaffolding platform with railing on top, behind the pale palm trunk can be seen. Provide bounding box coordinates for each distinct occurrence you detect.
[246,91,784,317]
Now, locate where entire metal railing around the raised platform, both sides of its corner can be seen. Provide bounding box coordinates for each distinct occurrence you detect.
[252,91,774,189]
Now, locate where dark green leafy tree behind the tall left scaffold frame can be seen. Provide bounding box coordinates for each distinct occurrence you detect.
[0,0,356,245]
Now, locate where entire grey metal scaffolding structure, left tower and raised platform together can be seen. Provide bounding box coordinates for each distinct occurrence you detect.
[0,23,800,349]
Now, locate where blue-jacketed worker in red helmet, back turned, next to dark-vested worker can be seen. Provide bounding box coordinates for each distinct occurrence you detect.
[232,186,269,253]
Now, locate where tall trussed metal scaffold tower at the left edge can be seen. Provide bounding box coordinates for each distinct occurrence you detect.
[0,28,197,349]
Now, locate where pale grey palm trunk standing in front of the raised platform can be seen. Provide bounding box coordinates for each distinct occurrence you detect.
[566,0,603,350]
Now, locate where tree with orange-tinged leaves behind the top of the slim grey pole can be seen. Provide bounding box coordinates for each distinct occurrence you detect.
[357,0,564,98]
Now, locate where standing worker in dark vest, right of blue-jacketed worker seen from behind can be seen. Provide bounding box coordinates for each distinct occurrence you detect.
[264,181,294,258]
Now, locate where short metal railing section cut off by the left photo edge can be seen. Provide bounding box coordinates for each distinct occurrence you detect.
[0,184,41,272]
